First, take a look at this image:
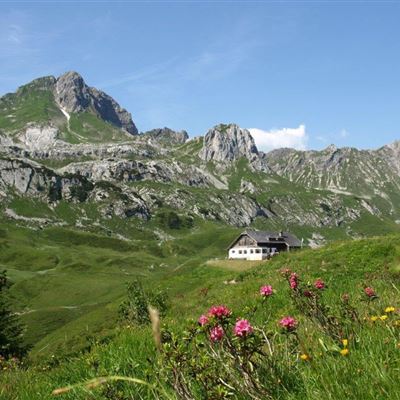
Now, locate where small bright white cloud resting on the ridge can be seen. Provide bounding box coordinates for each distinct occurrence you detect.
[249,125,308,152]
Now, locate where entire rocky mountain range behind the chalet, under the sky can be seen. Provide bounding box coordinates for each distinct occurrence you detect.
[0,73,400,244]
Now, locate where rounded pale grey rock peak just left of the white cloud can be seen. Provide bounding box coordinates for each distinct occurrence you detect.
[199,124,258,162]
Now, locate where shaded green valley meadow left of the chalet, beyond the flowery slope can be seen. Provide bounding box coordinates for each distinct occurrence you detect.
[0,223,235,358]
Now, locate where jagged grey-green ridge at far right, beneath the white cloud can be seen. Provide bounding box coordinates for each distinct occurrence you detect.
[264,143,400,198]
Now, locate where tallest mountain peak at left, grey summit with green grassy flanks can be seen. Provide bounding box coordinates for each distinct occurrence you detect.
[0,71,138,144]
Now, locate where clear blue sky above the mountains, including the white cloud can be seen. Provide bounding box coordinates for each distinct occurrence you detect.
[0,0,400,150]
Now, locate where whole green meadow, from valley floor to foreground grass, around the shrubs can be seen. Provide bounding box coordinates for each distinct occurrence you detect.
[0,225,400,400]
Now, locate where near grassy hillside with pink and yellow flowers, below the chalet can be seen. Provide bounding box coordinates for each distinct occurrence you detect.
[0,236,400,399]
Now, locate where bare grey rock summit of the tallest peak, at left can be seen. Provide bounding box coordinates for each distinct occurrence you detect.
[54,72,138,135]
